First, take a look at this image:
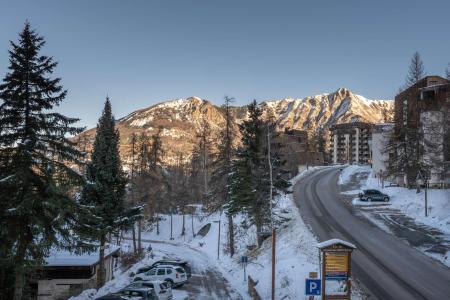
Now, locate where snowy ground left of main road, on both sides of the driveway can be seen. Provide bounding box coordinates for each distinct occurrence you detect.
[71,168,368,300]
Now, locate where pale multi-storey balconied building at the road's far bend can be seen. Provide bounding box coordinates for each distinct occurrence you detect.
[330,122,374,164]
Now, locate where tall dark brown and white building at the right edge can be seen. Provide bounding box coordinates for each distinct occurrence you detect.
[395,76,450,186]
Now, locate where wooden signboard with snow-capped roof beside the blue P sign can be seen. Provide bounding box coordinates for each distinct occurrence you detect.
[318,239,356,300]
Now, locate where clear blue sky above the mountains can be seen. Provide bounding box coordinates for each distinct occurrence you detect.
[0,0,450,127]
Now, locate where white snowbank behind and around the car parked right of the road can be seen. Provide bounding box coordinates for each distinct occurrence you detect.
[338,165,450,234]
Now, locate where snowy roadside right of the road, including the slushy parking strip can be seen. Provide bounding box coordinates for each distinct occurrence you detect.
[338,165,450,267]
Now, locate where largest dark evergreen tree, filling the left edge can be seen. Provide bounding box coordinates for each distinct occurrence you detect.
[0,22,83,300]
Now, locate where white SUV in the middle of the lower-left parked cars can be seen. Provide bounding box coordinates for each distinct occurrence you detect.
[134,265,187,287]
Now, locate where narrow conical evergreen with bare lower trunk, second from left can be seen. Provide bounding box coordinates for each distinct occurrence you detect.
[82,98,134,287]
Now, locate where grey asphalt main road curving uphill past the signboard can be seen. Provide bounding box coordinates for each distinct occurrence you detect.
[294,168,450,300]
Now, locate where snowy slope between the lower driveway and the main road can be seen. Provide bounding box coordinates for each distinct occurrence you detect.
[138,169,319,299]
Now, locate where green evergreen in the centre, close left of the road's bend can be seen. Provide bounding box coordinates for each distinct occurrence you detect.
[227,101,289,246]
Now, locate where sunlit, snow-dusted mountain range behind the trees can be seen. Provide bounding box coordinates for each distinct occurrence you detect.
[80,88,393,164]
